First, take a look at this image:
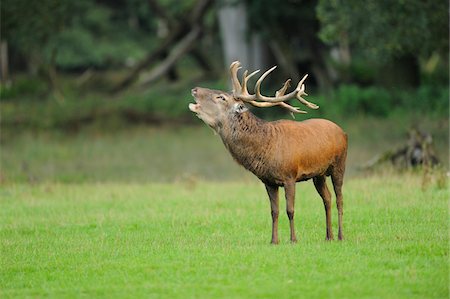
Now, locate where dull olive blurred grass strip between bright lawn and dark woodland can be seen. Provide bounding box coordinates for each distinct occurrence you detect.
[0,116,449,183]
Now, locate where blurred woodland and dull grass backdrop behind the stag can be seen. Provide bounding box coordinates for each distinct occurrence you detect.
[0,0,449,183]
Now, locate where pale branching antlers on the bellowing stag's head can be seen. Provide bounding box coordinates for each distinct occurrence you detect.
[230,61,319,113]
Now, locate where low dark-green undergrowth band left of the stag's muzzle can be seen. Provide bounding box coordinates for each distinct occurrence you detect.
[0,72,229,130]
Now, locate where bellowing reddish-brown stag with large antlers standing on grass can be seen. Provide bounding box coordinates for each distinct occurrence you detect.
[189,61,347,244]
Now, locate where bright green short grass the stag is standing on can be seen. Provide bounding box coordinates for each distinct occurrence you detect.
[0,175,449,298]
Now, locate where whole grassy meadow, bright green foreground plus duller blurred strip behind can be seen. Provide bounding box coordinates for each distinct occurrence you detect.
[0,117,450,298]
